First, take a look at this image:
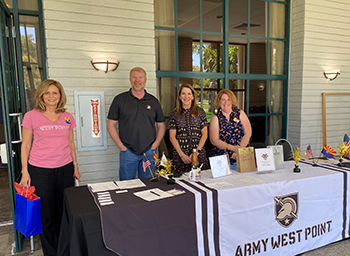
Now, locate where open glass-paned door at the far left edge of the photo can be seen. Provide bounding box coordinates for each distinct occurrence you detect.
[0,0,22,252]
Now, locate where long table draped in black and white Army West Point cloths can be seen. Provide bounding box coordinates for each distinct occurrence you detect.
[59,162,350,256]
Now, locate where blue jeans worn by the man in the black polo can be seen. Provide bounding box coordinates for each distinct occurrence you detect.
[119,149,156,180]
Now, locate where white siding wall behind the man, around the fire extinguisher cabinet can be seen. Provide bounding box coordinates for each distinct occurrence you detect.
[43,0,156,184]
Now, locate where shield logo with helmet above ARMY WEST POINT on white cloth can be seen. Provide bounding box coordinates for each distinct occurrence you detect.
[274,193,299,228]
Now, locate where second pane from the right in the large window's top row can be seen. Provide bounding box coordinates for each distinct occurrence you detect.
[250,0,268,37]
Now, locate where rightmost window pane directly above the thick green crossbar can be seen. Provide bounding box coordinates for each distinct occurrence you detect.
[270,40,285,75]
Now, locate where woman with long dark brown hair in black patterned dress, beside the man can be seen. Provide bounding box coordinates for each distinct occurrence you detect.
[169,84,209,174]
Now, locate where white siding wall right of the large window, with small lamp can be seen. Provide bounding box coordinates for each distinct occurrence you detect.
[288,0,350,155]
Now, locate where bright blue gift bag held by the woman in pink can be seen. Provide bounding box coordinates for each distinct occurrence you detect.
[15,193,42,237]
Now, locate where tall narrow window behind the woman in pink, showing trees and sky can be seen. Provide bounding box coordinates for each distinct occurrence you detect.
[19,15,43,110]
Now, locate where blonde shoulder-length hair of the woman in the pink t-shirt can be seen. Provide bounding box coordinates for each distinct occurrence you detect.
[34,79,67,113]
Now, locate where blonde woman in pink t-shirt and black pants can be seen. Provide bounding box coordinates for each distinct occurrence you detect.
[20,79,81,255]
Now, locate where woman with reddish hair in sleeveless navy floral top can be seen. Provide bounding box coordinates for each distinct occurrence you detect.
[209,90,252,170]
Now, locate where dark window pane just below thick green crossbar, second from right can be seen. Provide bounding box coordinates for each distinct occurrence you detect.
[249,80,266,114]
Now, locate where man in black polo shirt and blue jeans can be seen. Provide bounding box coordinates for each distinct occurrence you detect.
[107,67,165,180]
